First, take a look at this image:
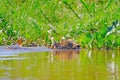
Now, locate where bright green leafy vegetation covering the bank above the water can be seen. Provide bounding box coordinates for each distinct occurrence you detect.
[0,0,120,48]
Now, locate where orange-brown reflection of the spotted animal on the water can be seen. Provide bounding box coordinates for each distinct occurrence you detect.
[53,50,80,60]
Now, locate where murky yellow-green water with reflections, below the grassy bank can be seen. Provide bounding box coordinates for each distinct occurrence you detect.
[0,50,120,80]
